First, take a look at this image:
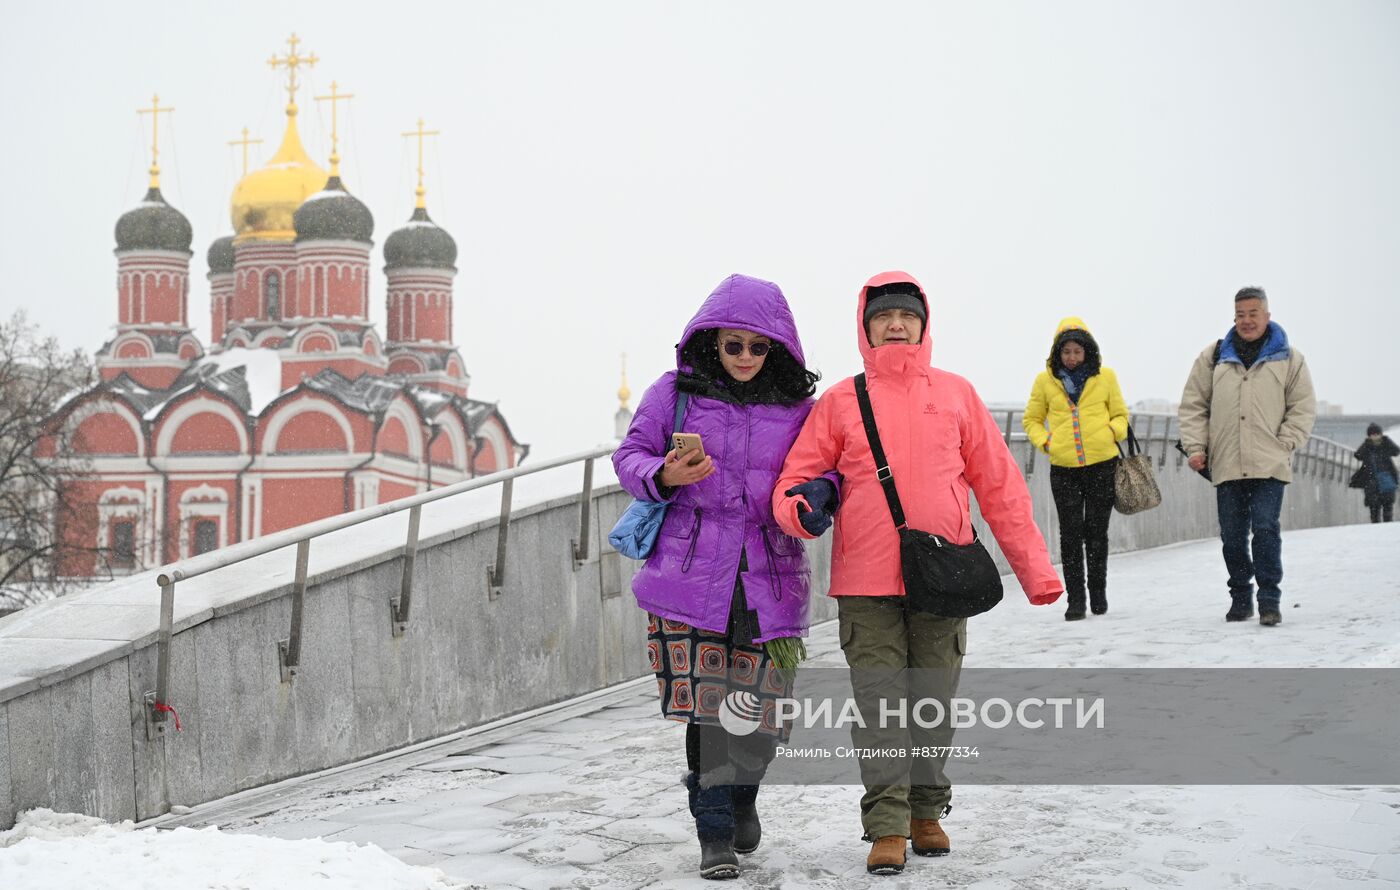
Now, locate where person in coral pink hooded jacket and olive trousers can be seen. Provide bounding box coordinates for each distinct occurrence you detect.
[773,271,1064,875]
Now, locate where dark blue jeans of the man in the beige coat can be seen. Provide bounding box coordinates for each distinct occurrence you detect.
[1215,479,1284,612]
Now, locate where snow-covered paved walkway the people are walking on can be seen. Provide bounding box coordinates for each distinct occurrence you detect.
[0,525,1400,890]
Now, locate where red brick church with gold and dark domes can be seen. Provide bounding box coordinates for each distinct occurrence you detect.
[41,35,528,578]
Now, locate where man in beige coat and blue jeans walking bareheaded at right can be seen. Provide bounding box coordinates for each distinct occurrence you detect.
[1177,287,1317,627]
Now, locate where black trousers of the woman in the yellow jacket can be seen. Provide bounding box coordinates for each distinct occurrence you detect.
[1050,458,1119,609]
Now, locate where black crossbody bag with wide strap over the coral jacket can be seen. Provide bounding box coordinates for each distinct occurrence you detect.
[855,374,1001,619]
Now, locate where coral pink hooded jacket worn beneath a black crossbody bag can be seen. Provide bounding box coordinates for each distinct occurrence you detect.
[773,271,1064,603]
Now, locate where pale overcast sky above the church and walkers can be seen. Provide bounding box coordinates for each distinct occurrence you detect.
[0,0,1400,455]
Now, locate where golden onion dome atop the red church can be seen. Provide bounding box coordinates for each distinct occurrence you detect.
[230,105,329,243]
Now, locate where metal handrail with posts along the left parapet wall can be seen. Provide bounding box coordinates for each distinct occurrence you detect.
[144,444,617,737]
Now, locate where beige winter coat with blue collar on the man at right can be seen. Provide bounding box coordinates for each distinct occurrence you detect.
[1177,325,1317,486]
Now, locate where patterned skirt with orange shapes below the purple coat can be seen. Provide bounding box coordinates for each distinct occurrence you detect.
[647,613,792,740]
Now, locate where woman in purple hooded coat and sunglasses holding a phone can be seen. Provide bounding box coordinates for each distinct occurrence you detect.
[613,276,836,877]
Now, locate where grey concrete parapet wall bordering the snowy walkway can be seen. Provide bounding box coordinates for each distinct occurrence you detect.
[0,428,1365,827]
